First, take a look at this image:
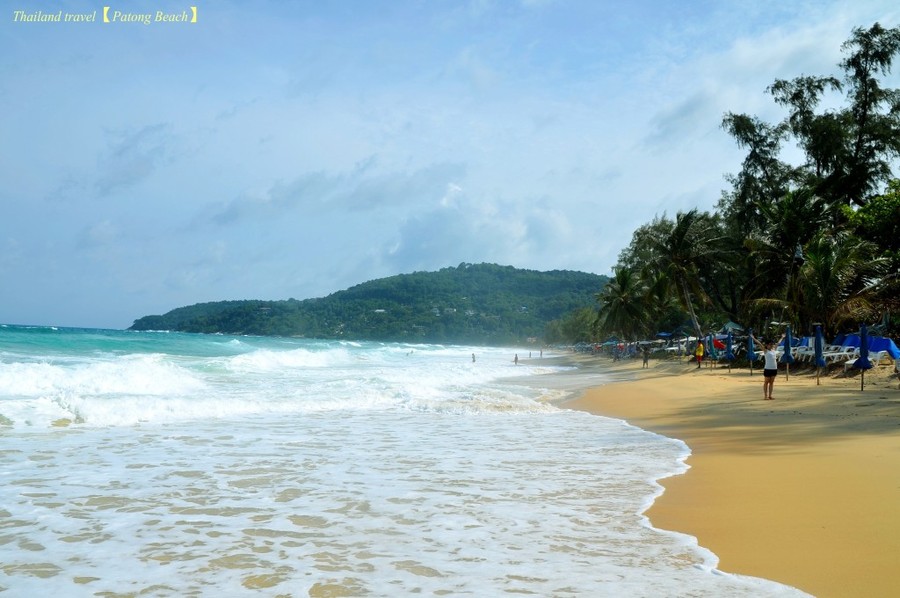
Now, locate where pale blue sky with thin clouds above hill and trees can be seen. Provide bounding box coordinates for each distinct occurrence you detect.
[0,0,900,328]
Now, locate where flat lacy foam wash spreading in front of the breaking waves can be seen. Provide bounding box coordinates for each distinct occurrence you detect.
[0,411,798,596]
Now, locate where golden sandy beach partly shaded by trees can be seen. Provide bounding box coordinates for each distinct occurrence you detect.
[565,358,900,597]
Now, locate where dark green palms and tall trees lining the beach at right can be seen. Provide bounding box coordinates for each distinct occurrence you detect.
[593,23,900,339]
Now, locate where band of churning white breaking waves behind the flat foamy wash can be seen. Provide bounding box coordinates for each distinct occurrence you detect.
[0,339,559,427]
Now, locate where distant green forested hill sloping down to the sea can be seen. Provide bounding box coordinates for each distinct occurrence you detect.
[129,264,608,344]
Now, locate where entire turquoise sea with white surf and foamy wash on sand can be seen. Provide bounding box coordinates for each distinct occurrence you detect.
[0,325,806,598]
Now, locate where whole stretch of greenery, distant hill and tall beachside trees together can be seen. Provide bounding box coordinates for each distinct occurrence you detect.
[132,23,900,344]
